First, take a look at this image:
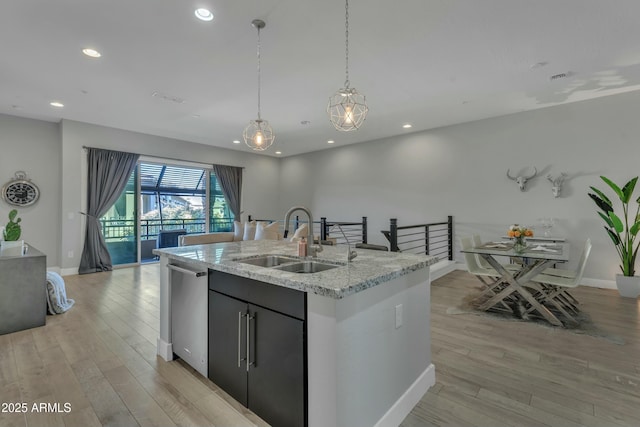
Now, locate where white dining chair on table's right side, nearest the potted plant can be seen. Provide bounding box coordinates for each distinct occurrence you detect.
[532,239,592,323]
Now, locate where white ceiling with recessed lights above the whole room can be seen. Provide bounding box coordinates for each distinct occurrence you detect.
[0,0,640,156]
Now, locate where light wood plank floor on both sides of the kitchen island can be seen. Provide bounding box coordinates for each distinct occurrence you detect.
[0,265,640,427]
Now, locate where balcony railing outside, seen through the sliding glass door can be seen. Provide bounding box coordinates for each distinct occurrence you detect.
[100,218,233,242]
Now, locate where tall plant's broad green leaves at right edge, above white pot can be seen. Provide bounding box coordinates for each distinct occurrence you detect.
[589,176,640,276]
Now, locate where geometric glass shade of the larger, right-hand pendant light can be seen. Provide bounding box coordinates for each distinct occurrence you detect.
[327,87,369,132]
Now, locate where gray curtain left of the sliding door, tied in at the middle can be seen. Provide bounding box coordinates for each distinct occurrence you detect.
[78,148,140,274]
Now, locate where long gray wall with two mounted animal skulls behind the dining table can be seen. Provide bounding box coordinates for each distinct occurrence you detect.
[280,92,640,286]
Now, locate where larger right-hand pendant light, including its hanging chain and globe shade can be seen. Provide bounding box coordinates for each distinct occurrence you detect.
[327,0,369,132]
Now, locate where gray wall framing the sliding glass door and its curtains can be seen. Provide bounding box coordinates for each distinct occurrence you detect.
[60,120,280,272]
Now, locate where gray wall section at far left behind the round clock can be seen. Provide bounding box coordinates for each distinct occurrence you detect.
[0,114,60,267]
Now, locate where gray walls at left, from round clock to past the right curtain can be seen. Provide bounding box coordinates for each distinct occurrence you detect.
[0,115,280,274]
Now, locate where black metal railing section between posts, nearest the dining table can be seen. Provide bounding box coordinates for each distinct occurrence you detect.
[382,216,453,261]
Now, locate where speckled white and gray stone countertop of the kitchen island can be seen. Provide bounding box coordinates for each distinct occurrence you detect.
[153,240,437,299]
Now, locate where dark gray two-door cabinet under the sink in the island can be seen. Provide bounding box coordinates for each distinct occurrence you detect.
[208,271,307,427]
